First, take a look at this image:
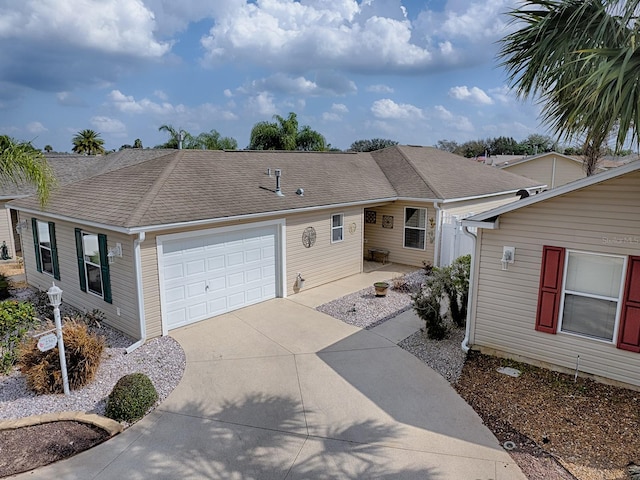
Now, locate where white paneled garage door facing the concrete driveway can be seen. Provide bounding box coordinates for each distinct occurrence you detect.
[160,226,276,330]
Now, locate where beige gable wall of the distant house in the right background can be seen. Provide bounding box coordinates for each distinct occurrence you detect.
[504,155,585,188]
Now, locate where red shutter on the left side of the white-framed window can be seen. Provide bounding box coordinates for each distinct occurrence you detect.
[536,246,564,333]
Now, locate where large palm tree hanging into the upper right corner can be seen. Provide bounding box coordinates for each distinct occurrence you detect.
[499,0,640,174]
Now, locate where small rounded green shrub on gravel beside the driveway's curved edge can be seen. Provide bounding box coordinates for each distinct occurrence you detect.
[105,373,158,422]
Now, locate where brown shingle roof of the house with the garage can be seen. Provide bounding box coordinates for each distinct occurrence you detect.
[11,147,536,228]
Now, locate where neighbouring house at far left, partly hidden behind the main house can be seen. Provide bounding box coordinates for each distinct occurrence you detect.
[0,149,172,259]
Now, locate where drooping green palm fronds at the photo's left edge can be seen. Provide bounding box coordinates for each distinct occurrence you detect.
[0,135,56,206]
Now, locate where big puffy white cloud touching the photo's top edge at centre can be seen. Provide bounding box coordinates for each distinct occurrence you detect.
[201,0,431,71]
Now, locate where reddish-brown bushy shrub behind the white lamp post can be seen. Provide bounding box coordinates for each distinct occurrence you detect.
[18,317,104,394]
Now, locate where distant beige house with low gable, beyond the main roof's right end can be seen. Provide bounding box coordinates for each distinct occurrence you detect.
[493,152,602,188]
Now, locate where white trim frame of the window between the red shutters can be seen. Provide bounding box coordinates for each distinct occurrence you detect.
[557,248,629,346]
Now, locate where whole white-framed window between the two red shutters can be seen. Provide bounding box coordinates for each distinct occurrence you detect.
[558,250,626,343]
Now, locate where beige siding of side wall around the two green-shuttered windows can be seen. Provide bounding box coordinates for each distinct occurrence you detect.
[20,215,140,339]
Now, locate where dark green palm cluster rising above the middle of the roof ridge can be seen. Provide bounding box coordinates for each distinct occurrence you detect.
[248,112,327,151]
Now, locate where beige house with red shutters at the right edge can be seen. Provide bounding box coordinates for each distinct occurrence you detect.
[463,162,640,387]
